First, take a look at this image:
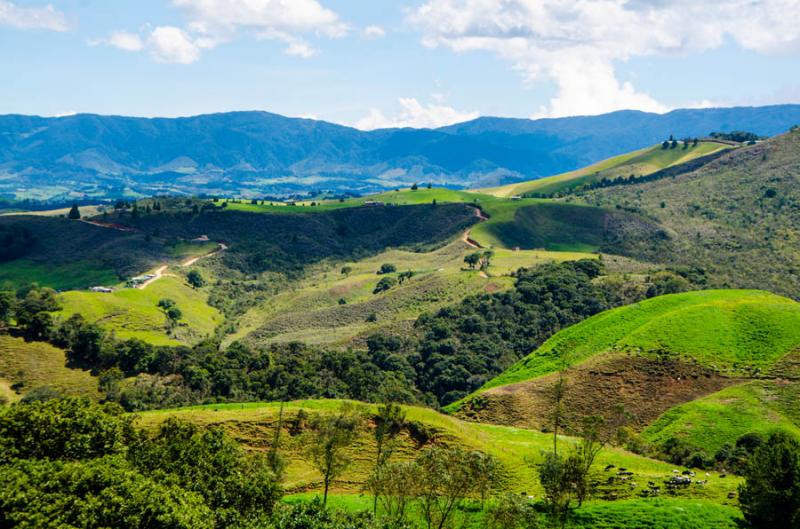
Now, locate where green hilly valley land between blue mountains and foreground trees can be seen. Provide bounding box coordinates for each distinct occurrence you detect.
[0,126,800,529]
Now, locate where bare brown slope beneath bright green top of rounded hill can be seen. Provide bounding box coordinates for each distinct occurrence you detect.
[459,356,740,430]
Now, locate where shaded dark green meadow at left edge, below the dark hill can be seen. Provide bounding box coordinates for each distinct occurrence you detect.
[0,259,119,290]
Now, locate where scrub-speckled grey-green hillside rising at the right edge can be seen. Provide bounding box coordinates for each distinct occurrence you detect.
[576,130,800,298]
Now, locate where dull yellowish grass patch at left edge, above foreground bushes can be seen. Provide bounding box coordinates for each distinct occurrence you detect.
[0,335,99,400]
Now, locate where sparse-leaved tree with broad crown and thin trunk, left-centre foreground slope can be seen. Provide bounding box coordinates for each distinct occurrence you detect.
[304,403,363,506]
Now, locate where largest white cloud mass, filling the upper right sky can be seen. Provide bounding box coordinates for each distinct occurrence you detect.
[410,0,800,116]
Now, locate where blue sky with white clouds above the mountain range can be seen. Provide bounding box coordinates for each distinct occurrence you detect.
[0,0,800,129]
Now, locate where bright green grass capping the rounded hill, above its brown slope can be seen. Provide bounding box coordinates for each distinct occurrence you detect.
[468,290,800,391]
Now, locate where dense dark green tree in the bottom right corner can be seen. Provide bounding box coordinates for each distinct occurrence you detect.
[739,431,800,529]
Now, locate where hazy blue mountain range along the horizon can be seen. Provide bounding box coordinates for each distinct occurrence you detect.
[0,105,800,200]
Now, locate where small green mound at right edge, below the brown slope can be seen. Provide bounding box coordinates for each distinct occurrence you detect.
[642,381,800,454]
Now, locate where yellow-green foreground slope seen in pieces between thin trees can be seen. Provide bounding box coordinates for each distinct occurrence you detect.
[134,401,738,503]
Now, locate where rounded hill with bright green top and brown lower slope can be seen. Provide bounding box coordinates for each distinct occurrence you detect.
[448,290,800,434]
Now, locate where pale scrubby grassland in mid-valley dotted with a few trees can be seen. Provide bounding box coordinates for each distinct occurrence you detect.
[227,237,596,345]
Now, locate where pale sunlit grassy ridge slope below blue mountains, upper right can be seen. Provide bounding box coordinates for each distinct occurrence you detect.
[482,142,730,197]
